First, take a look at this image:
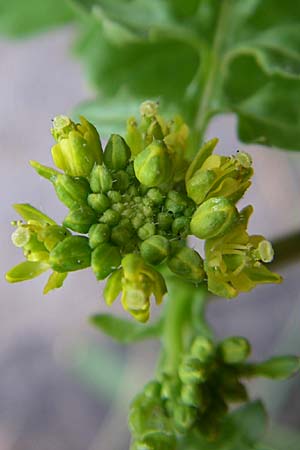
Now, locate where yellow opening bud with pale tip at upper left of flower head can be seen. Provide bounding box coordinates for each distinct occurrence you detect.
[52,116,102,177]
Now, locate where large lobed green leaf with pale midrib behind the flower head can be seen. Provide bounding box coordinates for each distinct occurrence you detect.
[71,0,300,150]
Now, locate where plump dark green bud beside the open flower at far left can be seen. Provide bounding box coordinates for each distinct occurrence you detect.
[49,236,91,272]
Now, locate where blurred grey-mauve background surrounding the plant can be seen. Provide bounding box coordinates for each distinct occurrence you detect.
[0,22,300,450]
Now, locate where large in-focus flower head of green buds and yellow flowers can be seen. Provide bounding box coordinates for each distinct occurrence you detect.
[7,101,281,322]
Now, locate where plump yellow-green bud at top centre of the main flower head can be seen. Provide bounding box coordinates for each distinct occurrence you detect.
[134,142,172,187]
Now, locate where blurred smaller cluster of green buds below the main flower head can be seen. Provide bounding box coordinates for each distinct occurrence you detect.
[129,336,299,450]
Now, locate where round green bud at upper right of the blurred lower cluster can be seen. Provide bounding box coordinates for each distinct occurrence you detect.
[219,336,251,364]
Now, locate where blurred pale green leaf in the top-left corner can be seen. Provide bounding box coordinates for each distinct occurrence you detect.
[0,0,74,37]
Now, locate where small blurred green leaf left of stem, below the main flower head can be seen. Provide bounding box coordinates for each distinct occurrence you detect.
[90,314,162,344]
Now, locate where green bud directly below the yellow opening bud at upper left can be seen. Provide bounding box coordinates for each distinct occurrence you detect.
[53,174,91,209]
